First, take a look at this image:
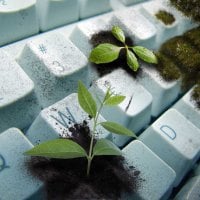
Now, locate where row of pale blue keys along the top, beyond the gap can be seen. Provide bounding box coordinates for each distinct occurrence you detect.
[0,0,148,46]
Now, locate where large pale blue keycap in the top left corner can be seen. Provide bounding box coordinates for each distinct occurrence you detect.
[0,0,39,46]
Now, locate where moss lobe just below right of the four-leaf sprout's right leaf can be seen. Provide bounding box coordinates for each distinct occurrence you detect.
[156,53,181,81]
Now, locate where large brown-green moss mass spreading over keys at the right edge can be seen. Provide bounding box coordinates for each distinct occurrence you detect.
[156,27,200,109]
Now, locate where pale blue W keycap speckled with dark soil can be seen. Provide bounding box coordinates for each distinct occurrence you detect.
[26,93,112,145]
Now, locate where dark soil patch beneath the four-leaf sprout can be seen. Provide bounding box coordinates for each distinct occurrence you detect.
[90,31,142,78]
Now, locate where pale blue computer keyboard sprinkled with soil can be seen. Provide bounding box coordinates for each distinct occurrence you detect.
[0,0,200,200]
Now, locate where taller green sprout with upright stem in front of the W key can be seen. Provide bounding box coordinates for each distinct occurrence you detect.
[25,81,136,176]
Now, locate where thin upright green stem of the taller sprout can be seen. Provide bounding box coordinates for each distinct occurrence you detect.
[87,101,104,176]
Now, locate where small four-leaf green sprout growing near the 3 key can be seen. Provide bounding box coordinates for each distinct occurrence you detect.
[89,26,158,71]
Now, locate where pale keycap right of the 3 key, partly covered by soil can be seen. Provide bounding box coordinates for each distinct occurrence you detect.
[69,18,109,57]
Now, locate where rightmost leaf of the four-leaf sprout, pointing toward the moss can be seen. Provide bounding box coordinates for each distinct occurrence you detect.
[132,46,158,64]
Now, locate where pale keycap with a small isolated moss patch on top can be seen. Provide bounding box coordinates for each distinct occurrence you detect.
[141,1,179,49]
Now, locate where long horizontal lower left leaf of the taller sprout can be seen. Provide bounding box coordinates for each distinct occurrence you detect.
[25,139,87,159]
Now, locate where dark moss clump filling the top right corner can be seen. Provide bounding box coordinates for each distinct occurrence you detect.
[170,0,200,22]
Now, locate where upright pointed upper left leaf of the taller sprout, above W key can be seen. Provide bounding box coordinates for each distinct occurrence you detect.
[78,81,97,117]
